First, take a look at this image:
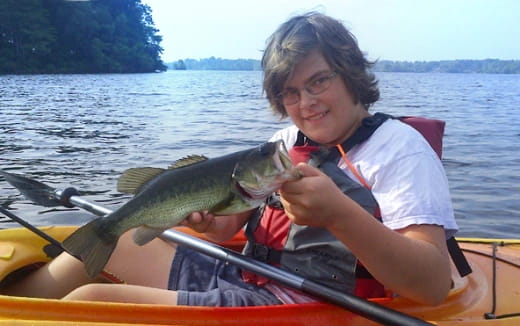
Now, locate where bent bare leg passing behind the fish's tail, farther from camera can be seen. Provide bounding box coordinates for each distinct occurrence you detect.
[2,231,176,302]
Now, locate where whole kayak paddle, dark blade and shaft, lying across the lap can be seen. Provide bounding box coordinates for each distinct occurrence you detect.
[0,170,433,326]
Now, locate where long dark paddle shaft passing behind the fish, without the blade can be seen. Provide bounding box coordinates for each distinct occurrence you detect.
[56,190,432,325]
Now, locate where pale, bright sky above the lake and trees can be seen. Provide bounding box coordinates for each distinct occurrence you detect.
[141,0,520,62]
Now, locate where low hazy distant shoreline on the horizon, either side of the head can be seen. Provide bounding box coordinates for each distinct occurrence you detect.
[166,57,520,74]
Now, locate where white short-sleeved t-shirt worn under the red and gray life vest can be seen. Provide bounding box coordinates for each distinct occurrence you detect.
[270,119,458,238]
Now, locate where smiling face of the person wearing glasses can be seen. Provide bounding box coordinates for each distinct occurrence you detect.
[283,50,369,147]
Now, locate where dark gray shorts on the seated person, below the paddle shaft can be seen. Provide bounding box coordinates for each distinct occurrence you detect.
[168,246,282,307]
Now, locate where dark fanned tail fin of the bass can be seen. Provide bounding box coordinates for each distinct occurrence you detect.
[63,218,119,278]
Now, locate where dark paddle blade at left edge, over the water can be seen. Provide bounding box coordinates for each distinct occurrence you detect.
[0,170,62,207]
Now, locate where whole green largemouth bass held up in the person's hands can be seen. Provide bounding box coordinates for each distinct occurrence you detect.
[63,141,300,277]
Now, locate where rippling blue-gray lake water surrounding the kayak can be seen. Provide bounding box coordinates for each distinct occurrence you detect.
[0,71,520,238]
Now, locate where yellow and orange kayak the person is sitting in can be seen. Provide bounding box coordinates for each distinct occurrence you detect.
[0,226,520,326]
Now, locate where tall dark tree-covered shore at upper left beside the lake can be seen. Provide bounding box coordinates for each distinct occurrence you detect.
[0,0,166,74]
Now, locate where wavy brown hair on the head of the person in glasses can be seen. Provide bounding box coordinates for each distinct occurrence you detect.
[262,12,379,118]
